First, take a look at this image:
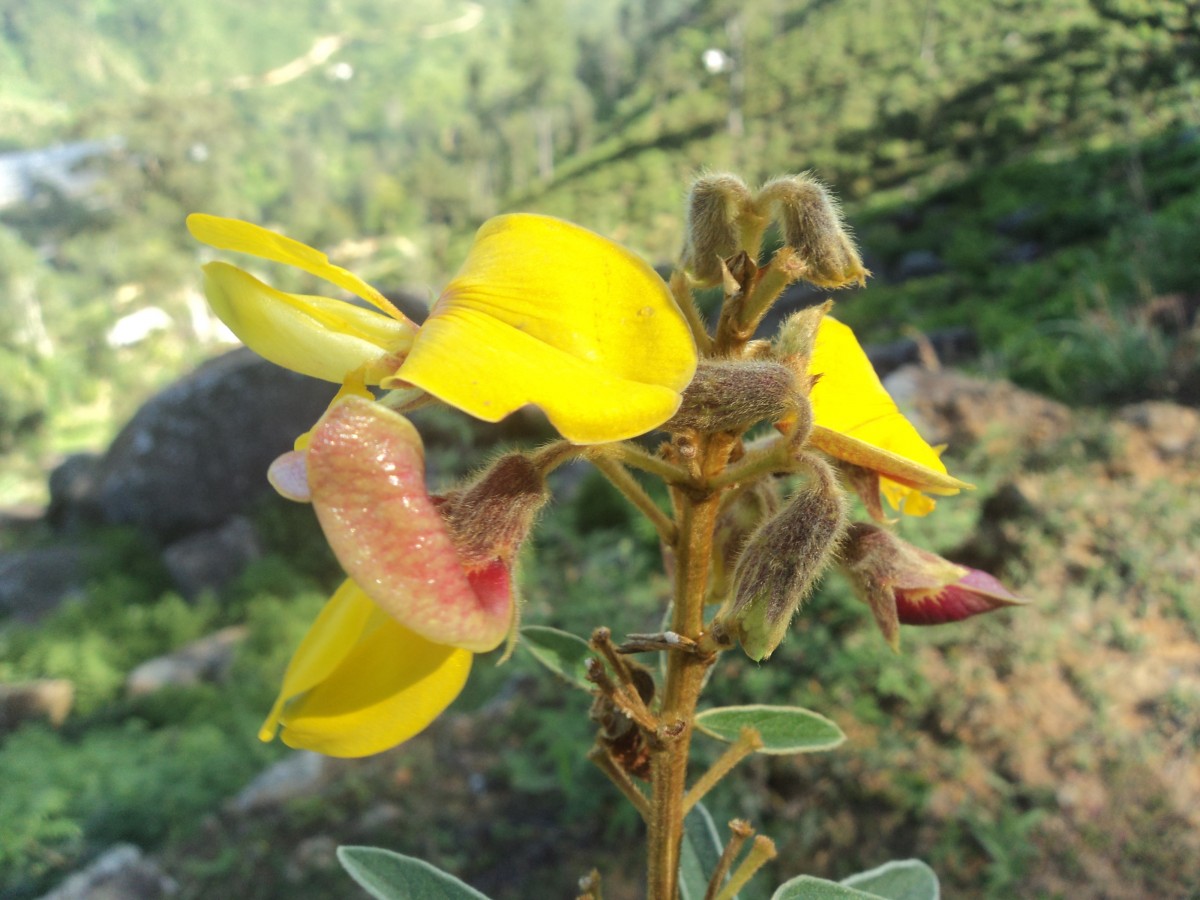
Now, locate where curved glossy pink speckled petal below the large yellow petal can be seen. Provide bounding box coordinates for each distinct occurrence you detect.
[308,397,511,653]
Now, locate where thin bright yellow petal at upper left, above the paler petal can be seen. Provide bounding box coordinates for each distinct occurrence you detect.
[187,212,408,322]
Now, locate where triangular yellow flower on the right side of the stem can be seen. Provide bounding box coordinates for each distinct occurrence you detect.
[809,316,971,516]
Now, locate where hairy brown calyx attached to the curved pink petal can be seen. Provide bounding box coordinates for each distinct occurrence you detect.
[438,452,550,569]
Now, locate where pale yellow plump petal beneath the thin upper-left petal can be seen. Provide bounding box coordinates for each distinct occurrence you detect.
[204,263,415,384]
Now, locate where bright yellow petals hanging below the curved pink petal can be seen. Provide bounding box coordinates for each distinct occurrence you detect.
[259,581,472,756]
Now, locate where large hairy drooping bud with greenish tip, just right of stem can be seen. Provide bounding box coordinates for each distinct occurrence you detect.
[718,460,846,660]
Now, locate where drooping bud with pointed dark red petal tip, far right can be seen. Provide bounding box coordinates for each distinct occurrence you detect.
[842,522,1028,649]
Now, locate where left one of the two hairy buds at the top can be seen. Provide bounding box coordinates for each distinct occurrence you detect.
[683,174,755,286]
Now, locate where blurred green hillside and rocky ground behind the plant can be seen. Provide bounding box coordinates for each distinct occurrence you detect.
[0,0,1200,900]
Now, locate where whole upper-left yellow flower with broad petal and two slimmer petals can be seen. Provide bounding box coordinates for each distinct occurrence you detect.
[187,214,696,444]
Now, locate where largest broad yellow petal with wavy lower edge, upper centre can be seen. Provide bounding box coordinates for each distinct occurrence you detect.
[396,215,696,444]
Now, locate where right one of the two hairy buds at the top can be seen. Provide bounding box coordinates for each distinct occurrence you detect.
[756,175,869,288]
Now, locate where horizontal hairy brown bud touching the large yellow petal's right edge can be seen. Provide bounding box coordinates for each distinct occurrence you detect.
[662,360,806,434]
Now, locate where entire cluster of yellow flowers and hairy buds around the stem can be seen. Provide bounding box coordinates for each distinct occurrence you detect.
[187,176,1015,756]
